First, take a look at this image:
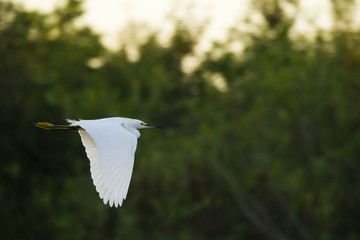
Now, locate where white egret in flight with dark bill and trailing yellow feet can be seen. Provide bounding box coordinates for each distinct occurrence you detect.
[35,117,161,207]
